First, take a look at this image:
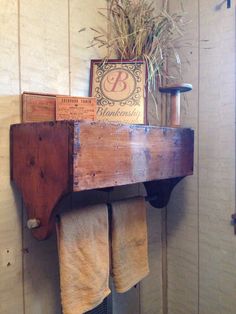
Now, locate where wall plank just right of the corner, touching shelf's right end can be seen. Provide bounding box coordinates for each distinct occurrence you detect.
[167,0,199,314]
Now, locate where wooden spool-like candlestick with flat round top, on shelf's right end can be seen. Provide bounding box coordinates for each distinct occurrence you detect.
[159,84,193,128]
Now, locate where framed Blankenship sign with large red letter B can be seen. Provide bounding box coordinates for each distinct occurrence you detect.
[90,60,147,124]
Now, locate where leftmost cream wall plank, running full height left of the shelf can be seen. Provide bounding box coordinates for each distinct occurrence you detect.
[0,0,23,314]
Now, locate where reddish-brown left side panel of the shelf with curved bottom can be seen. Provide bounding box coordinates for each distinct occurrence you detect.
[11,122,71,239]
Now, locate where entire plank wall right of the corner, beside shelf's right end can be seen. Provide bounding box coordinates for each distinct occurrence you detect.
[168,0,236,314]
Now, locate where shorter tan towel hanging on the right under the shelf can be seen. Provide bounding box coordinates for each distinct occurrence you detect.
[112,197,149,293]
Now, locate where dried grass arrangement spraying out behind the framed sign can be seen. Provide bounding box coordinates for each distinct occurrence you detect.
[87,0,186,90]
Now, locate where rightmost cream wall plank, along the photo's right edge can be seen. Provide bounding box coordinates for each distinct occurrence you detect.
[199,0,236,314]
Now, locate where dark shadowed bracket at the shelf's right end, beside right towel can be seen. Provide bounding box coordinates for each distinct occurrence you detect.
[144,177,184,208]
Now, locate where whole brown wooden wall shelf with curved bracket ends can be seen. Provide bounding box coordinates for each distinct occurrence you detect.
[10,121,194,240]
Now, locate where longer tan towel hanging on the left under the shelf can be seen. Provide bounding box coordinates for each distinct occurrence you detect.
[57,204,110,314]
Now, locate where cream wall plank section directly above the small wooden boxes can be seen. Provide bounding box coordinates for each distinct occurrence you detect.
[20,0,69,95]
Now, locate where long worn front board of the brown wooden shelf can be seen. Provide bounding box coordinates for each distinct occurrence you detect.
[73,122,193,191]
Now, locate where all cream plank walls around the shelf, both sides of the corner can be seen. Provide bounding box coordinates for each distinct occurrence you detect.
[0,0,236,314]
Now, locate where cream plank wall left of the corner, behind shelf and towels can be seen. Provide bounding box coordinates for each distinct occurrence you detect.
[0,0,162,314]
